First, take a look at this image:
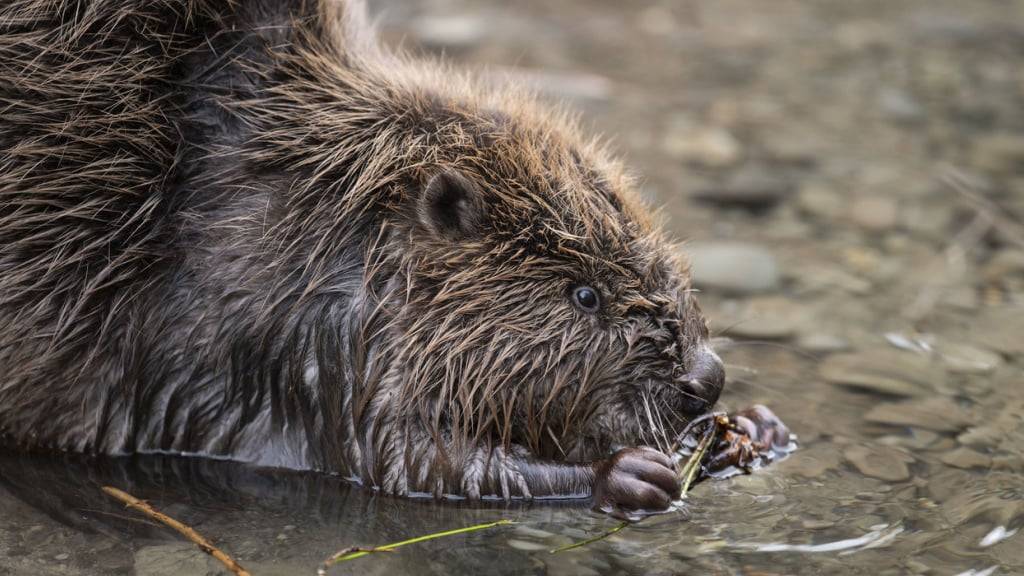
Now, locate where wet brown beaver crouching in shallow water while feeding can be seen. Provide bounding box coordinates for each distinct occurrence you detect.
[0,0,788,509]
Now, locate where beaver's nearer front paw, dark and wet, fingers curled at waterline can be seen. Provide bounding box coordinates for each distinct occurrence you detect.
[594,448,680,518]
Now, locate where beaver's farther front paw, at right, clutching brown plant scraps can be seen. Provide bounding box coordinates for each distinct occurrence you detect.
[708,404,792,472]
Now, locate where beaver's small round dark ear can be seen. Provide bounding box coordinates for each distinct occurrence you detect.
[419,170,483,240]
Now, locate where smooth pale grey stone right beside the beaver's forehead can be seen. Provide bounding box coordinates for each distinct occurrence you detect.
[685,242,779,294]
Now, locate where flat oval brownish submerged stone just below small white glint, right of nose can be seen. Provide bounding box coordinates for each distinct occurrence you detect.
[818,348,945,396]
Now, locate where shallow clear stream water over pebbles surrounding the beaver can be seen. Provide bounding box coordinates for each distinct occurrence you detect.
[0,0,1024,576]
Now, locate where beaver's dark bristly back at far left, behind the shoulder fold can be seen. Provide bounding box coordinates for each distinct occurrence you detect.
[0,0,296,449]
